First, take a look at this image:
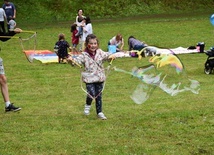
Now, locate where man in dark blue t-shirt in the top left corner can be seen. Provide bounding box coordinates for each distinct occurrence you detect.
[2,0,16,29]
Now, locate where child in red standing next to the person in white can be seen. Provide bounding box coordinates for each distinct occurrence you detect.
[71,24,79,53]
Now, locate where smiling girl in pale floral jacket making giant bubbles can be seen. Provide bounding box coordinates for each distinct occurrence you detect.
[68,34,115,120]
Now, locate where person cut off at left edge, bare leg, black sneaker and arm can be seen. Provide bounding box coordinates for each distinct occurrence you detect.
[0,28,22,112]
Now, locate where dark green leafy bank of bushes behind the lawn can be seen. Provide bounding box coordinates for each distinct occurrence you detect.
[9,0,214,23]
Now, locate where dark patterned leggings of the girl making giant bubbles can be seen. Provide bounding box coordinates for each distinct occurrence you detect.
[86,82,103,114]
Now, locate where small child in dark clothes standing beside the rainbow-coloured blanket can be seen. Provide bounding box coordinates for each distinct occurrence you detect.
[54,33,72,63]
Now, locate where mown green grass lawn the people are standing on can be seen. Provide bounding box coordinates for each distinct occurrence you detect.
[0,14,214,155]
